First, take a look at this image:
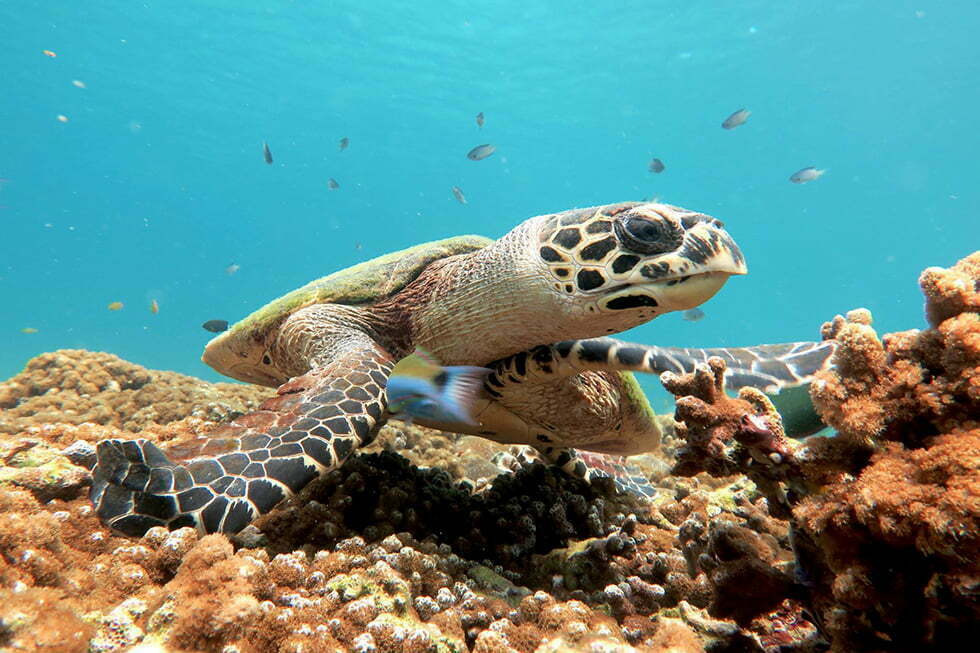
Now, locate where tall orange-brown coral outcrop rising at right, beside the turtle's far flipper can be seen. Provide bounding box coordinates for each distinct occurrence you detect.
[664,252,980,651]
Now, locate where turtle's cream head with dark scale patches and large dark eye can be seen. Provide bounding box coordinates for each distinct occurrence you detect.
[537,203,747,326]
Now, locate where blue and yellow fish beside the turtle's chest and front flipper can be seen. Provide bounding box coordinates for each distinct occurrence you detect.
[385,351,490,424]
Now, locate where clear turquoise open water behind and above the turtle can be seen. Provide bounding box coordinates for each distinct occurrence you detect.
[0,0,980,408]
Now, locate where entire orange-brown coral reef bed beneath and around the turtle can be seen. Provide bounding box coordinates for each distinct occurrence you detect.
[0,253,980,653]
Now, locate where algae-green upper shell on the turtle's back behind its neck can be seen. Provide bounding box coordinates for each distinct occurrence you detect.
[228,235,493,337]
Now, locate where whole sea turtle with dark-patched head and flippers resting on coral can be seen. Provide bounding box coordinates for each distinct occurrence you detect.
[91,202,830,535]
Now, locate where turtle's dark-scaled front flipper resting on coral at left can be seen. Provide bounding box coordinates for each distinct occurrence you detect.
[91,339,393,536]
